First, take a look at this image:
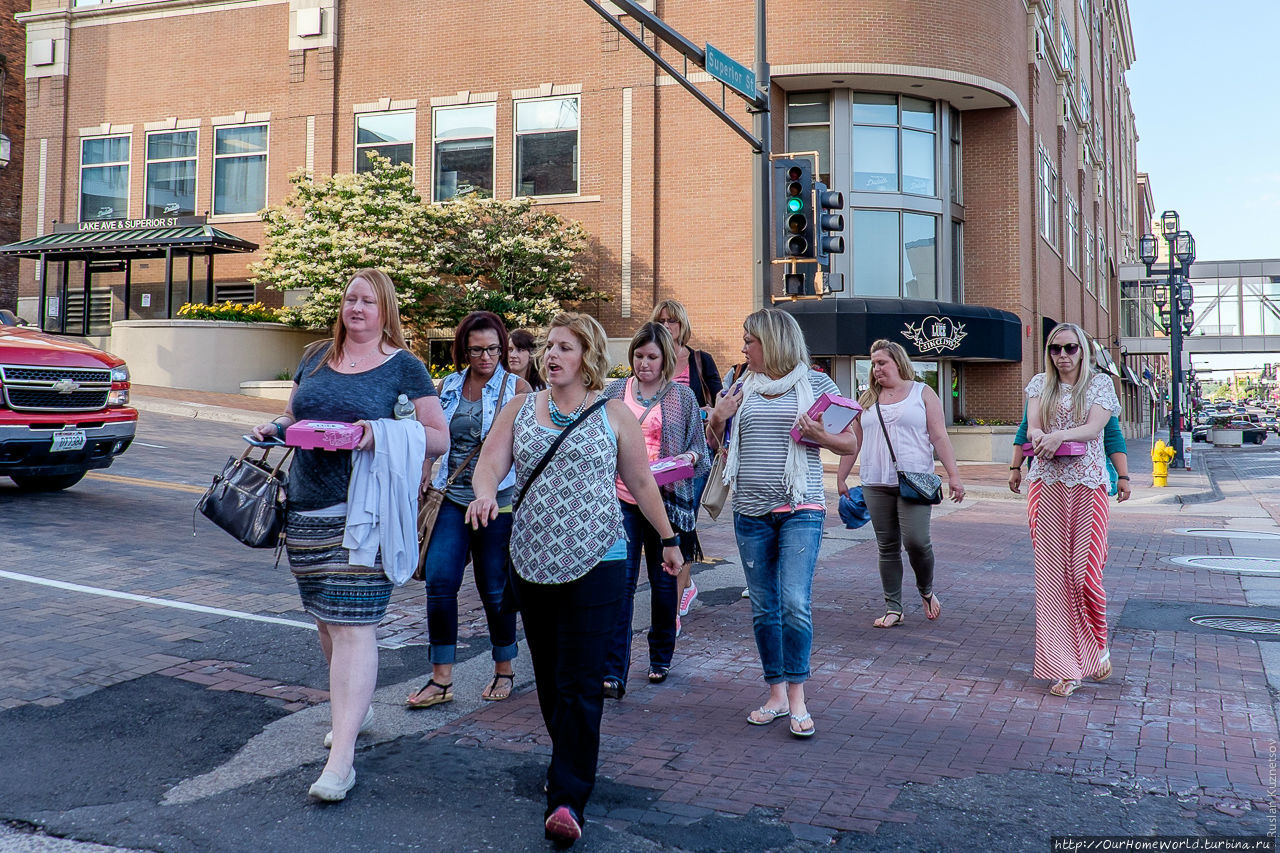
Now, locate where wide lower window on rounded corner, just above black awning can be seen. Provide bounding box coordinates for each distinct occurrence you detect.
[852,210,938,300]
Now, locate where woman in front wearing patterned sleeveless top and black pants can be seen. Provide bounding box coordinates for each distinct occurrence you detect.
[467,313,684,845]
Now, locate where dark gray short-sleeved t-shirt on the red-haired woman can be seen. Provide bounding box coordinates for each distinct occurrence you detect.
[287,348,436,511]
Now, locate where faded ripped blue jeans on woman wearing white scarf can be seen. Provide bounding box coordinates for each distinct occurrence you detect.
[733,510,827,684]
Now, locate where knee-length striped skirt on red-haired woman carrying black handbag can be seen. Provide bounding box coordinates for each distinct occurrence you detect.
[284,512,392,625]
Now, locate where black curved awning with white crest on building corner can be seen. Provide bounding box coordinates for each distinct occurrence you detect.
[780,297,1023,361]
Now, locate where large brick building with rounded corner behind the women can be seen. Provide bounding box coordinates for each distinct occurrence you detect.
[12,0,1140,420]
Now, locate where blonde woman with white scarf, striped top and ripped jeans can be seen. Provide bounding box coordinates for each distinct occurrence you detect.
[707,309,858,738]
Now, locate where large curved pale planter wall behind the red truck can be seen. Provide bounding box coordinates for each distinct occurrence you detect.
[109,320,326,396]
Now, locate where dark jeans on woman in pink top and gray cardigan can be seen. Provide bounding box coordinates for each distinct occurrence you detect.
[604,501,677,686]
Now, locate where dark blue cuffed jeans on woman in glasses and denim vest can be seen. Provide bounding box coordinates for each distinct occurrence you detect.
[425,498,516,663]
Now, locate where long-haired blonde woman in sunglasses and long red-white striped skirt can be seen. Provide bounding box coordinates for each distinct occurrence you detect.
[1027,323,1120,697]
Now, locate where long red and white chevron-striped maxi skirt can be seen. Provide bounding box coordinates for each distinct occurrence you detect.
[1027,480,1110,679]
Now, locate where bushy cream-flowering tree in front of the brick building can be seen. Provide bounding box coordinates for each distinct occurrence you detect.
[253,155,604,328]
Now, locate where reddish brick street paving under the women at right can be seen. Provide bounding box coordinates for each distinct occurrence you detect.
[435,502,1277,831]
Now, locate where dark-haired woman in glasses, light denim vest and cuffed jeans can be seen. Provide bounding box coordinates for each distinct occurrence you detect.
[406,311,530,708]
